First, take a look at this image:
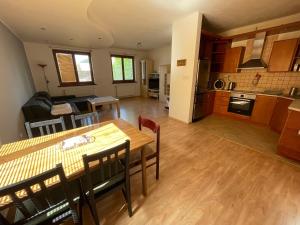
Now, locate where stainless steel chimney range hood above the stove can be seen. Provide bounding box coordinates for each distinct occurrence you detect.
[239,32,267,69]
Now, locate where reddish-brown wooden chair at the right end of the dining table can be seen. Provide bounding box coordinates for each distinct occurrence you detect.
[130,116,160,180]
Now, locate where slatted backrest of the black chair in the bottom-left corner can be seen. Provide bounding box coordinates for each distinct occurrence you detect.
[0,164,79,224]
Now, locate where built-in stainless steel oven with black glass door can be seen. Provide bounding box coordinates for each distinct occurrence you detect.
[228,92,256,116]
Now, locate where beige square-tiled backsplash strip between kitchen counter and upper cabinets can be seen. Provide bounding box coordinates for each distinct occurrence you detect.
[218,70,300,94]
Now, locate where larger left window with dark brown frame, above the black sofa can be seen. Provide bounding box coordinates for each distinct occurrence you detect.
[53,50,94,86]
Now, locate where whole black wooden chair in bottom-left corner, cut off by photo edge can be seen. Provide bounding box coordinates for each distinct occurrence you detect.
[0,164,83,225]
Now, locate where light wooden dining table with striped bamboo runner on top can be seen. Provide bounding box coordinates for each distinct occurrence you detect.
[0,119,154,209]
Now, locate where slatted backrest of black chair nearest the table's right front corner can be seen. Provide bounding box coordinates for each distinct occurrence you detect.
[82,140,130,197]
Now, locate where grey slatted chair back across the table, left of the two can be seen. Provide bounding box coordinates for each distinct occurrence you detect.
[25,117,66,138]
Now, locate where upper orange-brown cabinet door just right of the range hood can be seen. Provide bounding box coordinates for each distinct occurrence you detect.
[268,39,298,72]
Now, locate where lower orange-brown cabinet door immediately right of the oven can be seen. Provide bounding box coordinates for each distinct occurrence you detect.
[251,95,277,125]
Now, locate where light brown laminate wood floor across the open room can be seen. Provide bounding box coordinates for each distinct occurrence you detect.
[76,98,300,225]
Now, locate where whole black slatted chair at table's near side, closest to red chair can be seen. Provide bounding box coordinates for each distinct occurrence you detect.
[82,140,132,224]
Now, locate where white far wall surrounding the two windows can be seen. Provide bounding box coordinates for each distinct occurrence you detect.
[24,42,146,97]
